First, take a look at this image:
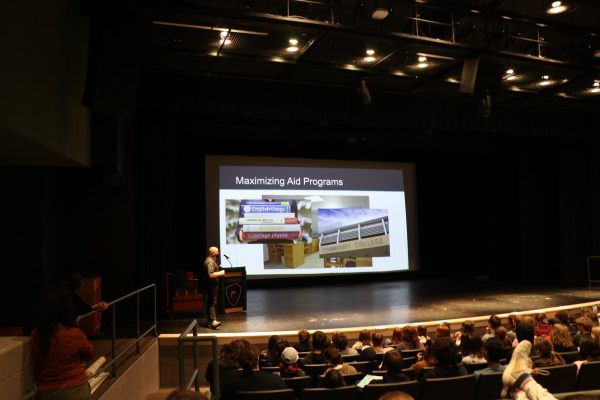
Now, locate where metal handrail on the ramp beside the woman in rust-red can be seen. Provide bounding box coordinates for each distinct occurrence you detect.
[77,283,158,378]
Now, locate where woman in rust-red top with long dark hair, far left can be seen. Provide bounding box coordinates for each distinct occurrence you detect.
[31,288,94,400]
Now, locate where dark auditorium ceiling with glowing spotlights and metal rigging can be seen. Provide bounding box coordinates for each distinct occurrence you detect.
[141,0,600,111]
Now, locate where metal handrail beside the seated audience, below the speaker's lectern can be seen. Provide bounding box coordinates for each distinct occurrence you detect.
[177,319,221,399]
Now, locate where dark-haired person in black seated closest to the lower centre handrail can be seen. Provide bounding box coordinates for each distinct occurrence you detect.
[221,339,287,400]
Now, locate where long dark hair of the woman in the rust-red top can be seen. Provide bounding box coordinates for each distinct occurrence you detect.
[37,287,77,354]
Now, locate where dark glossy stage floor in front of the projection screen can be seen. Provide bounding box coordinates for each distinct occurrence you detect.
[159,278,600,333]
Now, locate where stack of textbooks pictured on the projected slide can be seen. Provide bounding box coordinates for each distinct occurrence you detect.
[237,200,302,242]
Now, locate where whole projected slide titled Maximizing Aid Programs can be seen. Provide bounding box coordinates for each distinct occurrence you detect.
[218,165,408,277]
